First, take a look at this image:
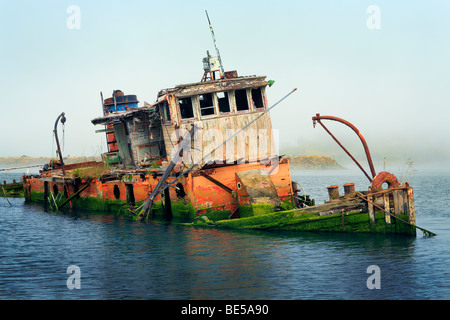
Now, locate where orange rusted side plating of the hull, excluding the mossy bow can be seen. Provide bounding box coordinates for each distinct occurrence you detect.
[23,159,293,218]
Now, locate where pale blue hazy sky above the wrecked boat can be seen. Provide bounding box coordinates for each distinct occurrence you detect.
[0,0,450,171]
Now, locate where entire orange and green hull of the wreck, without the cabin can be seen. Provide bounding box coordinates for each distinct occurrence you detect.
[23,159,417,236]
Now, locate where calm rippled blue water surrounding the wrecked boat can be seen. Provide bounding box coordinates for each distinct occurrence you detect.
[0,171,450,300]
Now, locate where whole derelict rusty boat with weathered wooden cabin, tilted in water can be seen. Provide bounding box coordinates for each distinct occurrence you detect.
[22,15,433,236]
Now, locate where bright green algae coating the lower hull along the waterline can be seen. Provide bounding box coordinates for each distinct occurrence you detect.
[25,191,416,235]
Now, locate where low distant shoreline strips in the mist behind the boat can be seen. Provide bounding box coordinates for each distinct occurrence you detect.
[0,155,345,170]
